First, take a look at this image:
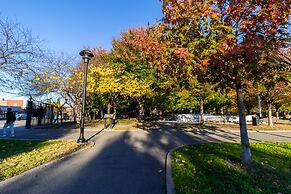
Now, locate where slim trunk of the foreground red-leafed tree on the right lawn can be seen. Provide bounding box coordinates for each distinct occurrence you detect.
[236,86,252,163]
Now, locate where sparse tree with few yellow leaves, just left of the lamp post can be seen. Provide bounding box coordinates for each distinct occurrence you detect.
[26,53,82,120]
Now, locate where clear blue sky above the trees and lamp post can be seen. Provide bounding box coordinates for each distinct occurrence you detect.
[0,0,162,54]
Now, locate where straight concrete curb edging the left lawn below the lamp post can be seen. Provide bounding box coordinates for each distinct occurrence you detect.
[0,141,95,188]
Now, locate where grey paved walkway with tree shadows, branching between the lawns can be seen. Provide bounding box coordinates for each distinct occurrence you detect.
[0,123,291,194]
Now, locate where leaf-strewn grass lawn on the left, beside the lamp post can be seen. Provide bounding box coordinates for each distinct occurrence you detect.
[0,140,89,181]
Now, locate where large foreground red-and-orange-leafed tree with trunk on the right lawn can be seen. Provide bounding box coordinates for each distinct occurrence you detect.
[162,0,290,163]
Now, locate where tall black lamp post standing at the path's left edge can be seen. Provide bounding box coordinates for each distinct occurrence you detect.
[77,49,94,143]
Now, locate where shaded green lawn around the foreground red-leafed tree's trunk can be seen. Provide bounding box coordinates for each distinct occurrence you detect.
[172,143,291,194]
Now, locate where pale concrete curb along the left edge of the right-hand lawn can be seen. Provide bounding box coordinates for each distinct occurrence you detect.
[166,148,177,194]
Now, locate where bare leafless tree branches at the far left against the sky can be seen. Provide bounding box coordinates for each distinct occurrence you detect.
[0,15,43,92]
